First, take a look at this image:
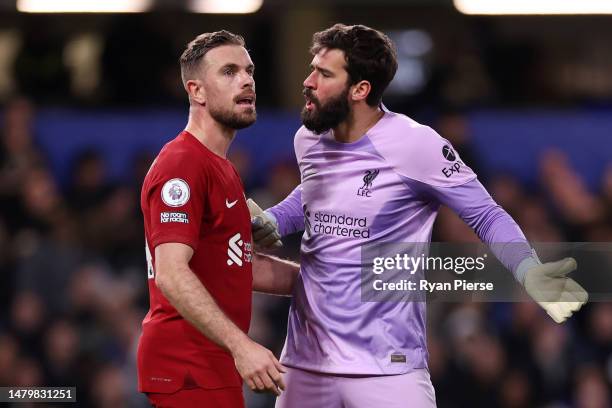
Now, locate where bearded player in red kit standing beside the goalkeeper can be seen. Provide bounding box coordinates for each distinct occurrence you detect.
[138,31,286,408]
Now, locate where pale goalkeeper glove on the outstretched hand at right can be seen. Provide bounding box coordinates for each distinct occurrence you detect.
[523,258,589,323]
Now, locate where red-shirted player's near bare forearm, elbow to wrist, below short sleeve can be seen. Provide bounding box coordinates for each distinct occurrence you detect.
[156,265,246,352]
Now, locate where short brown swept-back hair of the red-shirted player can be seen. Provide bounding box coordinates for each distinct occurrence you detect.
[179,30,244,84]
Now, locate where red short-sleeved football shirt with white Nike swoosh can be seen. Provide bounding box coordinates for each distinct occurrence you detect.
[138,132,253,392]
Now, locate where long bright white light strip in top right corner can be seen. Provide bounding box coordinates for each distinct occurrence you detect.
[453,0,612,15]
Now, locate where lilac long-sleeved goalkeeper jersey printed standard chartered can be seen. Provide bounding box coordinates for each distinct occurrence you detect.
[268,112,532,375]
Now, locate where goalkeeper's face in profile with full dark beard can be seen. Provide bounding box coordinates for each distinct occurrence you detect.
[301,48,351,134]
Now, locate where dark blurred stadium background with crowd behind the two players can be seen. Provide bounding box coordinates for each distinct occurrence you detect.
[0,0,612,408]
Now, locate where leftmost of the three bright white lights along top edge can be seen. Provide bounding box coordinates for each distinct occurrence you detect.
[17,0,151,13]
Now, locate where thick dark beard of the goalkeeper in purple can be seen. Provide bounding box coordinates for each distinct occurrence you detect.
[302,86,351,135]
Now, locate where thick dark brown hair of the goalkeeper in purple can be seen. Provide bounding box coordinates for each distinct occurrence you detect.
[310,24,397,106]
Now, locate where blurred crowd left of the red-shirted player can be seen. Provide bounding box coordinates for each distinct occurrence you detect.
[0,99,148,407]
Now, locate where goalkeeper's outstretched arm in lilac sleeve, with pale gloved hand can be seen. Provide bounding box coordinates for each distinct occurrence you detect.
[375,121,587,323]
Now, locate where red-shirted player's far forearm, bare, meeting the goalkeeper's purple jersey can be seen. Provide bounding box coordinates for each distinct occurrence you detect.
[253,253,300,296]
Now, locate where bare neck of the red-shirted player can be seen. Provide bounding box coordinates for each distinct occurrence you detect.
[185,106,236,159]
